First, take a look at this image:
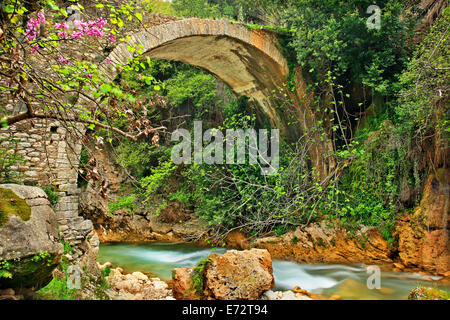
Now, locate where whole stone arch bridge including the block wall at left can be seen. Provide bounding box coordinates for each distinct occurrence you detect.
[0,18,328,243]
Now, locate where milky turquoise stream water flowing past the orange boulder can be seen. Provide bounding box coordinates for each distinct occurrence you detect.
[98,243,450,300]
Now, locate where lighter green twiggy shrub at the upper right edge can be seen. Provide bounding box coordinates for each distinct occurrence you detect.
[393,8,450,135]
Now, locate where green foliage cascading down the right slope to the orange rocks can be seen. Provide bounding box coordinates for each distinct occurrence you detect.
[316,9,450,245]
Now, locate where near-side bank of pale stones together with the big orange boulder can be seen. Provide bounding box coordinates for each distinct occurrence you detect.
[99,249,318,300]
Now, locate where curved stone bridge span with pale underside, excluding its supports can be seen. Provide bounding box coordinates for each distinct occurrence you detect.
[99,18,289,131]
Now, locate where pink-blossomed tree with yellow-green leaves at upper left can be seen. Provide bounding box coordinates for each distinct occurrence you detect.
[0,0,165,190]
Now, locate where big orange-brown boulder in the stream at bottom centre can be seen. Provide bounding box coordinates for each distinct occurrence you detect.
[204,249,275,300]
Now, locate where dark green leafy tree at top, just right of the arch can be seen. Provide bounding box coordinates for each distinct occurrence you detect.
[287,0,413,95]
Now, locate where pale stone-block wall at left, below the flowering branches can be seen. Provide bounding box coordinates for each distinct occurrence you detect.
[0,119,93,250]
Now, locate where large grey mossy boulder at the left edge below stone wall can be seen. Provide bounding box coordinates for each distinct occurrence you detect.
[0,184,64,289]
